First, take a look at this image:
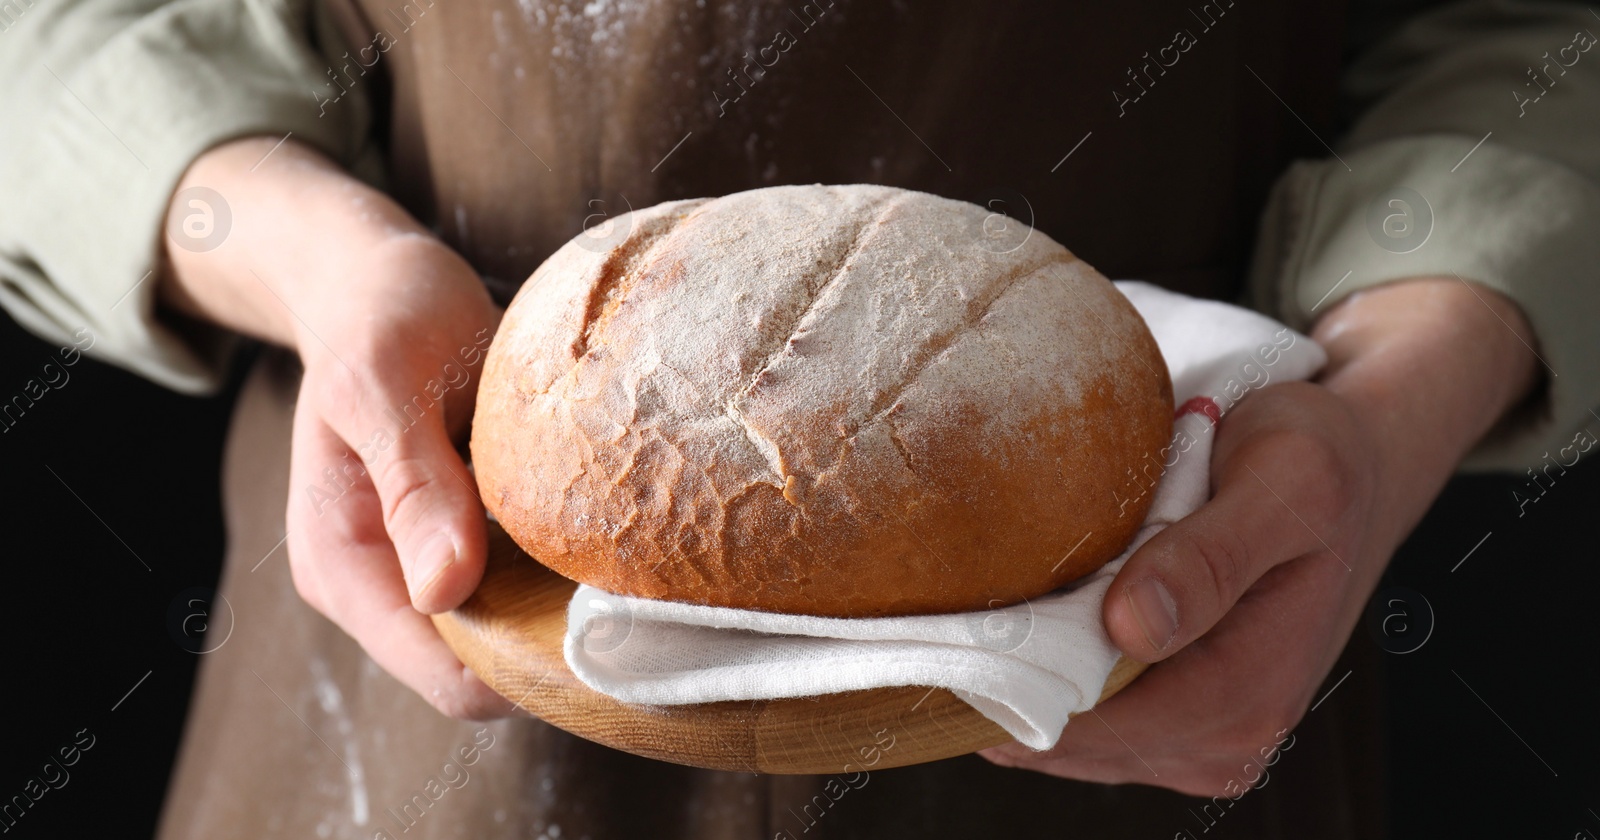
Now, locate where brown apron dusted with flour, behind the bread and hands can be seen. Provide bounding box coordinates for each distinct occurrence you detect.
[160,0,1382,840]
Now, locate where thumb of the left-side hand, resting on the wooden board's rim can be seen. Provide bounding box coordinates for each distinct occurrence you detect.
[312,369,488,613]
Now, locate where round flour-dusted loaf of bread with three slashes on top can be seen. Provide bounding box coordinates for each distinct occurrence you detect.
[472,186,1173,616]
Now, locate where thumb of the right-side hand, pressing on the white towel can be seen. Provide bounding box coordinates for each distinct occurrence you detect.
[1102,462,1317,662]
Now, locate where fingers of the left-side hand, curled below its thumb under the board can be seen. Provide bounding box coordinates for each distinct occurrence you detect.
[288,403,514,718]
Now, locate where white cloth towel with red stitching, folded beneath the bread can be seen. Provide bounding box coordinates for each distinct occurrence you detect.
[563,282,1326,749]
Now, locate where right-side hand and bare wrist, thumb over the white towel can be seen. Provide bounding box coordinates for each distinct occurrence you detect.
[982,278,1538,797]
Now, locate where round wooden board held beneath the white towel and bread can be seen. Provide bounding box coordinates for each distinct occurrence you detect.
[434,522,1146,773]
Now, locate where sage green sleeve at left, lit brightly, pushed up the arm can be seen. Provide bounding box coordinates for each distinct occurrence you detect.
[0,0,373,392]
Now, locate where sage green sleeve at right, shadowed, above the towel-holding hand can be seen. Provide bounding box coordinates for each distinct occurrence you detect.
[1251,0,1600,472]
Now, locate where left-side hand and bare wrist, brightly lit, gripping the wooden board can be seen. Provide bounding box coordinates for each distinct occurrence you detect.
[162,139,512,718]
